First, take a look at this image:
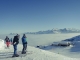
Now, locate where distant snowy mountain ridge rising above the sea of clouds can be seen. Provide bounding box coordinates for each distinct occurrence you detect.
[25,28,80,34]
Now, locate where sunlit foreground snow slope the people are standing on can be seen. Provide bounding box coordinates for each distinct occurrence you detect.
[0,44,80,60]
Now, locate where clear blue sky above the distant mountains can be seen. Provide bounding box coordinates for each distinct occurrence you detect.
[0,0,80,34]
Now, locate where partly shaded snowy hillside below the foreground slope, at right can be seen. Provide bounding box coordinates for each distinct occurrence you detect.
[37,35,80,58]
